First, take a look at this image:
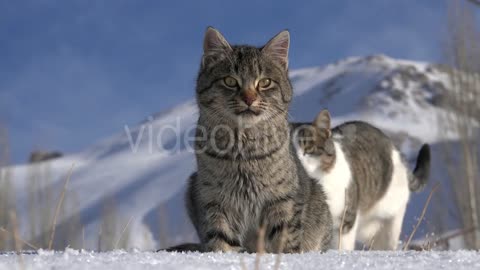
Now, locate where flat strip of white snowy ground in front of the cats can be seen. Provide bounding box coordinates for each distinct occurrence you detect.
[0,250,480,270]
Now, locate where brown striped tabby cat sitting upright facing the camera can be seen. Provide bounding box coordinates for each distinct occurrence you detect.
[182,27,332,253]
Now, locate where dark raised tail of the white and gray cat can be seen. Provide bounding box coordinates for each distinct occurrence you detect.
[408,144,430,192]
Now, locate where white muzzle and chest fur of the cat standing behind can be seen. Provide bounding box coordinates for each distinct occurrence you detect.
[297,138,353,226]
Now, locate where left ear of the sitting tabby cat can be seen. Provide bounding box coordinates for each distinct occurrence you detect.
[202,26,232,67]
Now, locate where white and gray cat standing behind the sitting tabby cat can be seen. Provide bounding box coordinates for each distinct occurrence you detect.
[293,110,430,250]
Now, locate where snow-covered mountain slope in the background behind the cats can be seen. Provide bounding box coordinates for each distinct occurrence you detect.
[1,56,464,249]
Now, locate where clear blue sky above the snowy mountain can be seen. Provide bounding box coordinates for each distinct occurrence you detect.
[0,0,446,163]
